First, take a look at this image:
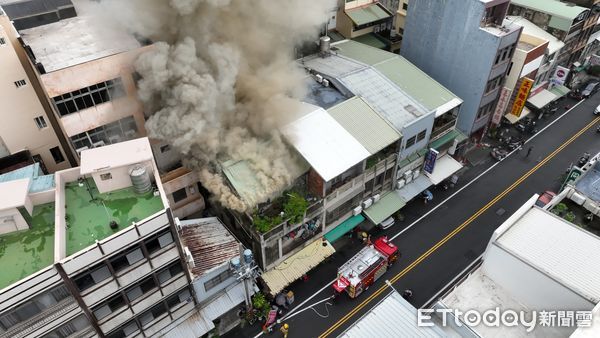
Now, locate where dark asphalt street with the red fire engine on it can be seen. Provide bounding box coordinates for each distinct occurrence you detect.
[226,95,600,338]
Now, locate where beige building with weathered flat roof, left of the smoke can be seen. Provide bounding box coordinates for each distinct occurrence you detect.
[19,17,151,162]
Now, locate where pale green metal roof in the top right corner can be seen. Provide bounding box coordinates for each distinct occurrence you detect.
[511,0,588,31]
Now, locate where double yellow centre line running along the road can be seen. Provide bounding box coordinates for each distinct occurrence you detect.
[319,117,600,338]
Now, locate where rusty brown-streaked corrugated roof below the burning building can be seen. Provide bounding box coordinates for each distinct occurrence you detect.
[181,217,240,277]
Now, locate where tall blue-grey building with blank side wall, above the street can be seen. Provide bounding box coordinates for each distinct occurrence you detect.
[401,0,522,136]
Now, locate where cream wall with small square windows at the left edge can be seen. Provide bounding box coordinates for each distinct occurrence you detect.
[0,15,70,172]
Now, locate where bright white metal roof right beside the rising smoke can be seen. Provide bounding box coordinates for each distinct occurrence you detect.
[281,104,371,181]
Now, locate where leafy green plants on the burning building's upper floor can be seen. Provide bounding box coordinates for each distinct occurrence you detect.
[252,191,308,234]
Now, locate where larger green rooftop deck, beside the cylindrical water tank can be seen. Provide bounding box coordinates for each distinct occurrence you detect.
[65,179,164,256]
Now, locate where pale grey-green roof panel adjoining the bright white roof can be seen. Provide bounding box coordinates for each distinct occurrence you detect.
[328,97,401,154]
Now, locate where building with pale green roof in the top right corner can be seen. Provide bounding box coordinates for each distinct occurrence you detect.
[509,0,598,68]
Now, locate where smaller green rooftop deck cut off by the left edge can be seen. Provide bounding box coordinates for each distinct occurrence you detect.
[0,202,54,289]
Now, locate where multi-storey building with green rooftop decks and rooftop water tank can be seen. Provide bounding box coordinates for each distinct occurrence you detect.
[0,138,195,337]
